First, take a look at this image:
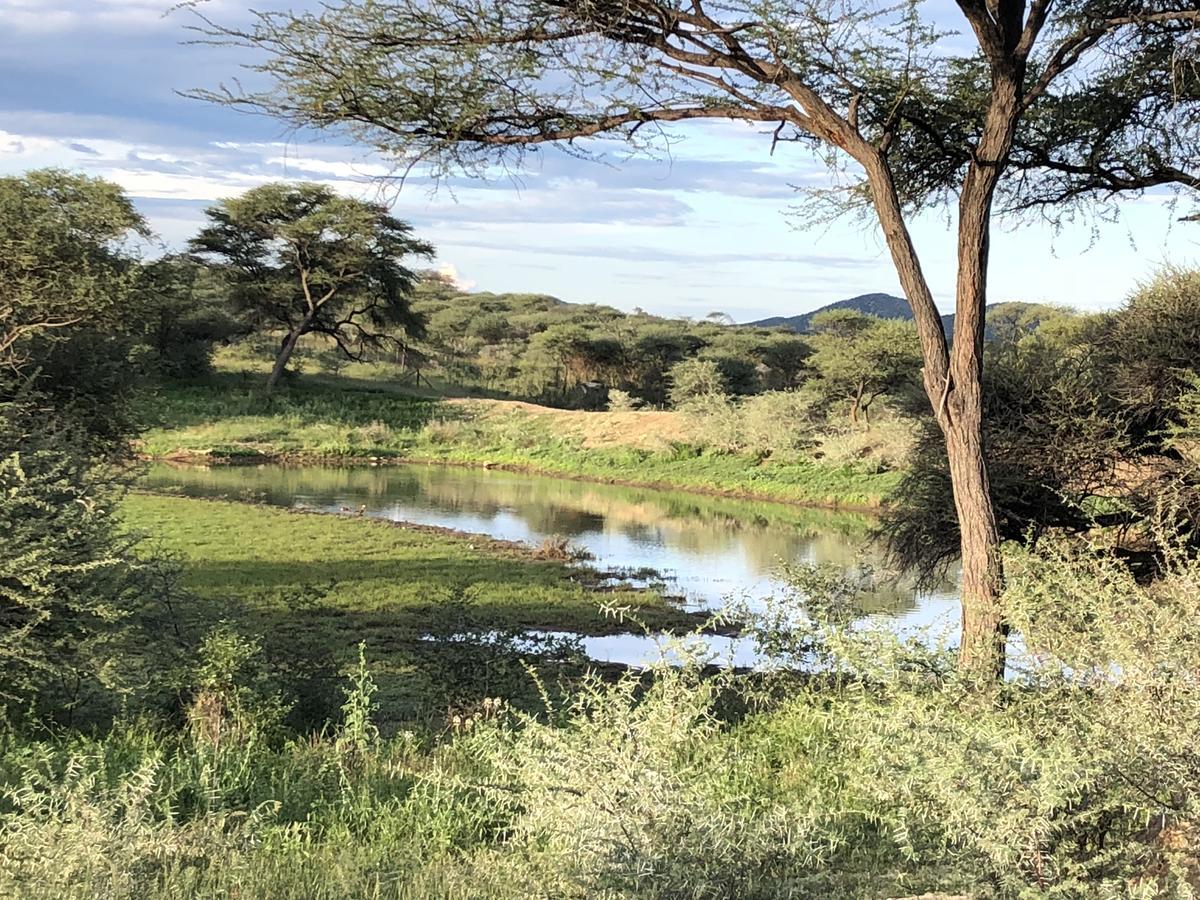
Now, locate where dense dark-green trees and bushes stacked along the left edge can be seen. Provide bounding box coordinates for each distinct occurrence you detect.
[0,170,188,722]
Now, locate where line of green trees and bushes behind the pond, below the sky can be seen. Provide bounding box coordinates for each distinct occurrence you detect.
[0,164,1200,710]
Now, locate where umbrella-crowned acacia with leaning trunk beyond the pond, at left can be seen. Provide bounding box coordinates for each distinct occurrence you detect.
[190,182,433,391]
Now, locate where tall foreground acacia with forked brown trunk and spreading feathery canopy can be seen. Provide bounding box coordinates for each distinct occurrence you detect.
[192,0,1200,673]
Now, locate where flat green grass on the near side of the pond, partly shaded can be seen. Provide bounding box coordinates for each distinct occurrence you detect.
[124,494,696,720]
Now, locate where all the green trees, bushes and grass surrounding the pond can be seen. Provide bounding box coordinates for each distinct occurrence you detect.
[0,0,1200,898]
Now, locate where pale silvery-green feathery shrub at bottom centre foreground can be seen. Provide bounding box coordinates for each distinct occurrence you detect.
[472,667,849,898]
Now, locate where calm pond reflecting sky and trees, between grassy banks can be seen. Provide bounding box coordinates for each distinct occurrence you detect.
[144,463,959,665]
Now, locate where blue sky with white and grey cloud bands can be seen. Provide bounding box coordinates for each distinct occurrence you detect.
[0,0,1200,322]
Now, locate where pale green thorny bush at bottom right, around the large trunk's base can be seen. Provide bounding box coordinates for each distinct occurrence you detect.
[734,541,1200,898]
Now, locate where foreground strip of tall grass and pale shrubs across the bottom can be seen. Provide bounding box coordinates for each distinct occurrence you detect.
[0,545,1200,898]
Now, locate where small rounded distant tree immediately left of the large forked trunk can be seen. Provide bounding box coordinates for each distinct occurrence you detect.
[809,310,920,424]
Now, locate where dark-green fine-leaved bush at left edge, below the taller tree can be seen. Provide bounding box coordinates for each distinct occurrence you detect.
[0,417,146,720]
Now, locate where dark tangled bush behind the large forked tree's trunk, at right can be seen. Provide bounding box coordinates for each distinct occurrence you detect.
[884,270,1200,577]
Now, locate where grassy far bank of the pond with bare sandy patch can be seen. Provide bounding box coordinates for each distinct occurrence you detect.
[142,376,899,506]
